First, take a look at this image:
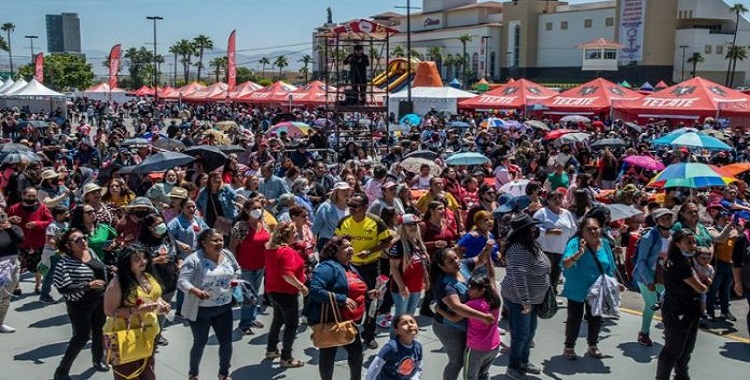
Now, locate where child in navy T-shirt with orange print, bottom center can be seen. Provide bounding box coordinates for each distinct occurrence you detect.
[367,314,422,380]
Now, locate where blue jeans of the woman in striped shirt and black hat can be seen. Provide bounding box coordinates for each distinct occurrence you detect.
[503,298,537,370]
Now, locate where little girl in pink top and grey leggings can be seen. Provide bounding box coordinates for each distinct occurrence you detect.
[464,275,500,380]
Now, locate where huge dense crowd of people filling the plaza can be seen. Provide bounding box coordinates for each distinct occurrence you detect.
[0,99,750,380]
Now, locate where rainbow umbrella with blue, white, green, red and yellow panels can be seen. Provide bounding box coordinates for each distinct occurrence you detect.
[648,162,736,189]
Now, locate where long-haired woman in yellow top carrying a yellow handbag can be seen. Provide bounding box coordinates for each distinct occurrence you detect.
[104,245,171,380]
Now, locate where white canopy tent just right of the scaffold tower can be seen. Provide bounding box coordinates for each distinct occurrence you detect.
[388,87,477,115]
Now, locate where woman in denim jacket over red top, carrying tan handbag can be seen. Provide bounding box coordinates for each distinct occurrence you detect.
[305,236,378,380]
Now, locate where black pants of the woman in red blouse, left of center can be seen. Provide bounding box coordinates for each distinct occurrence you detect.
[266,293,299,360]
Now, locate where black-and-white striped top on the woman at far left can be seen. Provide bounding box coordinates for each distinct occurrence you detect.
[53,252,107,302]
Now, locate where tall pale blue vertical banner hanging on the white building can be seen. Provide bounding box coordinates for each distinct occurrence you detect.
[618,0,647,63]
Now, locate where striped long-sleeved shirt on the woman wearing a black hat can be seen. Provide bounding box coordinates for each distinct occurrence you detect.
[501,243,552,305]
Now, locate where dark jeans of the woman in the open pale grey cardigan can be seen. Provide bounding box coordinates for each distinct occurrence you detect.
[190,304,233,376]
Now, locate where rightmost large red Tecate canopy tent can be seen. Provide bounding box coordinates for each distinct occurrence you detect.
[615,77,750,119]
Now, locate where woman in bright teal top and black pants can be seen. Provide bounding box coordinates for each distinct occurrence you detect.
[562,216,617,360]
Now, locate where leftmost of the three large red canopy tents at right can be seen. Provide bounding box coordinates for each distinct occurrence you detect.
[458,79,557,110]
